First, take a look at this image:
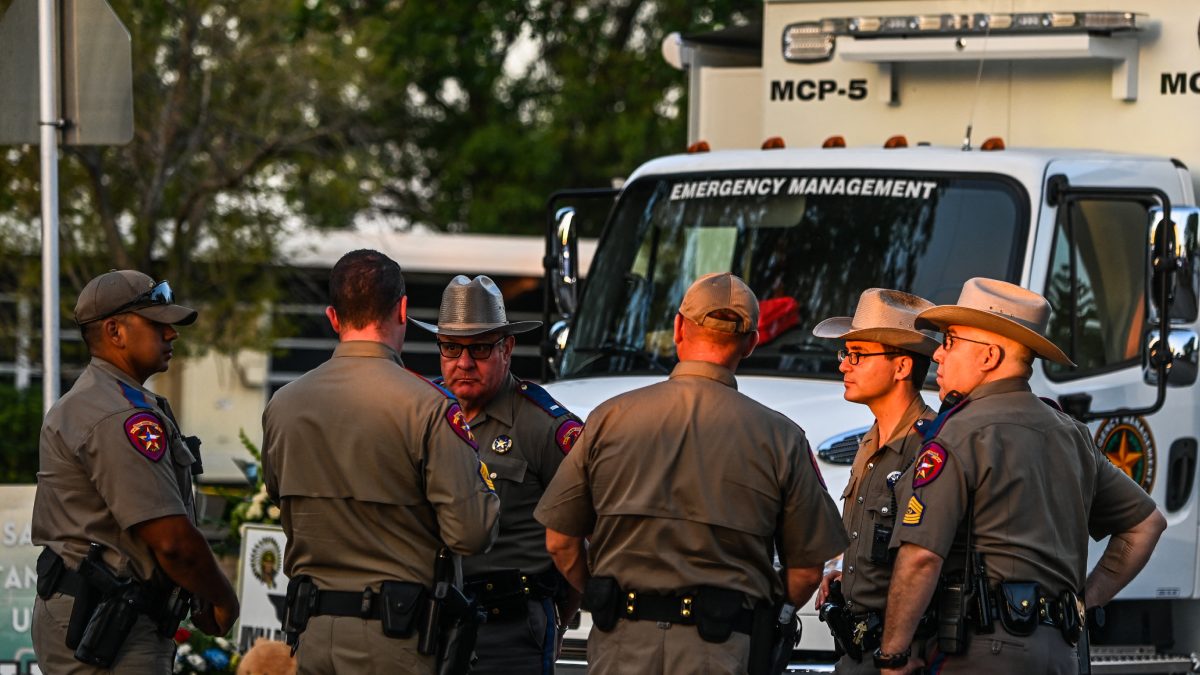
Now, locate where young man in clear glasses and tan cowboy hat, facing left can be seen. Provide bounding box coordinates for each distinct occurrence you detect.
[812,288,937,674]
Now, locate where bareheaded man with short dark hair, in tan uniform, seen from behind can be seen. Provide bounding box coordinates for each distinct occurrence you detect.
[263,250,499,675]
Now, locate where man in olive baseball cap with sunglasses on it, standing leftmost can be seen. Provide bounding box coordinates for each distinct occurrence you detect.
[32,270,238,674]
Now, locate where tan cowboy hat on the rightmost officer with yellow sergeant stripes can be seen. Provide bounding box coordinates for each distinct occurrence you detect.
[917,276,1075,366]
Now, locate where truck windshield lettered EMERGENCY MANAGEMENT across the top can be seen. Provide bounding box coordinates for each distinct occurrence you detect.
[562,172,1028,378]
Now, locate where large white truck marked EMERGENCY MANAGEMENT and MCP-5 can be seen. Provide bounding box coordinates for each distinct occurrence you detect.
[545,0,1200,673]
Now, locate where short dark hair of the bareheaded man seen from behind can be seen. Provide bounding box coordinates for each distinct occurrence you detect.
[329,249,404,329]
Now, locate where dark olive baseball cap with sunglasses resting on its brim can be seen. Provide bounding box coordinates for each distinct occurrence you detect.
[74,269,197,325]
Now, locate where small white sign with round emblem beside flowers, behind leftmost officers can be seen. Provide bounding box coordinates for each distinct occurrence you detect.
[235,525,288,653]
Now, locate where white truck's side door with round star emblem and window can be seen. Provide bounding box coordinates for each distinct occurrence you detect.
[1031,165,1200,599]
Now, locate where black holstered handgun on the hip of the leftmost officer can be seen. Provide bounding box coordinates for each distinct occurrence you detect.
[74,543,144,668]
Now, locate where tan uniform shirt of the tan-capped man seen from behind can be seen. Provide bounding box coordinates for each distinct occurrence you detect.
[534,362,846,599]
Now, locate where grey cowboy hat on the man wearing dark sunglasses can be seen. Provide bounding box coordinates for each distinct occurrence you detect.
[409,274,541,338]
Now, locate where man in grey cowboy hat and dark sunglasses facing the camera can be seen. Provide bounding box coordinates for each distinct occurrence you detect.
[413,275,583,675]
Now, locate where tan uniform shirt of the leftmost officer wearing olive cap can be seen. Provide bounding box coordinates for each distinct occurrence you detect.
[32,358,196,580]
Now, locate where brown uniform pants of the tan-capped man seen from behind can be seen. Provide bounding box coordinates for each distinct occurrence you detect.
[588,620,750,675]
